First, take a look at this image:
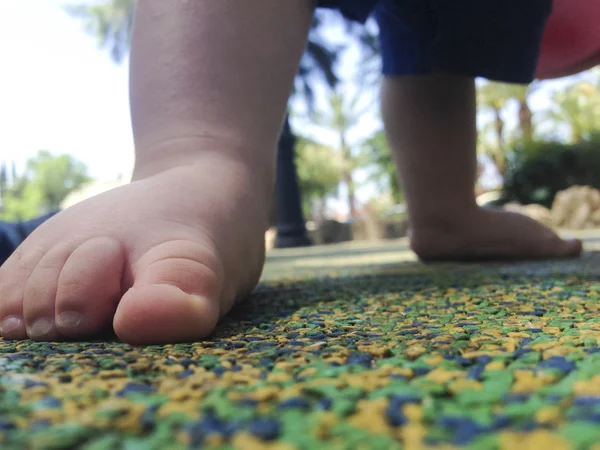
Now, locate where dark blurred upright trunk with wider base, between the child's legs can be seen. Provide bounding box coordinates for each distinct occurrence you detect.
[275,117,311,248]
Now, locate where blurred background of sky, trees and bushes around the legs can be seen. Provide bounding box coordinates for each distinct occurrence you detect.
[0,0,600,248]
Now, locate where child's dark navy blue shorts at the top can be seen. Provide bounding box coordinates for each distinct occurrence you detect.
[318,0,552,83]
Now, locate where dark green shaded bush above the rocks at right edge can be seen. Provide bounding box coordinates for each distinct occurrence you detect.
[503,138,600,208]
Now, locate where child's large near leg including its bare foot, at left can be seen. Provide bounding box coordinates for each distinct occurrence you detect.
[0,0,313,344]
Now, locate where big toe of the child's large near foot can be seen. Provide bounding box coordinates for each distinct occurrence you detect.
[113,241,223,345]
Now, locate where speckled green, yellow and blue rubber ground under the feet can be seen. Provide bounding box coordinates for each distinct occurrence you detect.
[0,237,600,450]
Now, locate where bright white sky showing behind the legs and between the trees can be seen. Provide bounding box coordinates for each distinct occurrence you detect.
[0,0,596,213]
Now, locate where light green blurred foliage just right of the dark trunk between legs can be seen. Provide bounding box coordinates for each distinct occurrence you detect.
[296,136,342,217]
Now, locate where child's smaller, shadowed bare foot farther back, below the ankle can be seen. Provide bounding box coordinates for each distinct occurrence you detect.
[411,209,582,262]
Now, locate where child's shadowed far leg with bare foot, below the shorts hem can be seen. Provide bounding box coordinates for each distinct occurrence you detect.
[382,75,581,260]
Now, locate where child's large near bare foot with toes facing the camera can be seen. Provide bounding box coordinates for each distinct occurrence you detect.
[0,153,270,344]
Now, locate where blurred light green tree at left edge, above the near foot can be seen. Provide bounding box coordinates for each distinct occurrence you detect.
[0,150,91,221]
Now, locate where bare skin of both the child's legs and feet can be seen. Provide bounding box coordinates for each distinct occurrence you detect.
[0,0,581,345]
